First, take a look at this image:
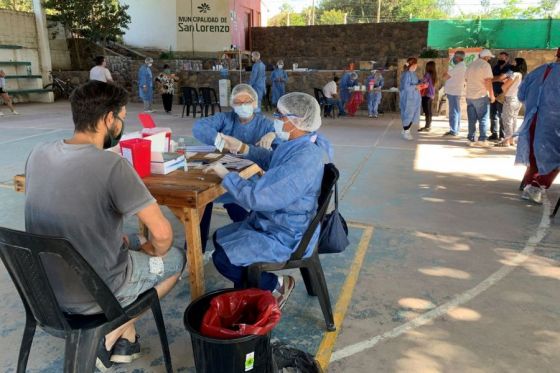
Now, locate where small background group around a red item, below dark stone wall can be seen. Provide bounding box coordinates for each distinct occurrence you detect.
[322,70,385,118]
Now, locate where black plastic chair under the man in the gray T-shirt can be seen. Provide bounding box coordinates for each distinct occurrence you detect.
[0,228,173,373]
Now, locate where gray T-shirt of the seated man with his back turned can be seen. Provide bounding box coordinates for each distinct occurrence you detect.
[25,140,155,313]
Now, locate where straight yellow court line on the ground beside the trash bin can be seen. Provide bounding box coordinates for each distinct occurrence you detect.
[315,223,373,372]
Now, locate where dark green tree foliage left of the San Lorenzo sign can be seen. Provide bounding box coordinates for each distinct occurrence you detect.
[45,0,130,43]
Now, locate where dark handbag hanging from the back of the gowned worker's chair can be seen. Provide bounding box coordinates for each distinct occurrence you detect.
[319,184,350,254]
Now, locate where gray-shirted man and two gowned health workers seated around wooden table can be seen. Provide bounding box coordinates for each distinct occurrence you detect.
[25,75,332,370]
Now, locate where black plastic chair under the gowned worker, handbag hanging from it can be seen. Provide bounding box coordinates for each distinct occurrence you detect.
[247,163,339,331]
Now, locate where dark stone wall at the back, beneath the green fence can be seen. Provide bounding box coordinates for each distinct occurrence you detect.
[252,22,428,70]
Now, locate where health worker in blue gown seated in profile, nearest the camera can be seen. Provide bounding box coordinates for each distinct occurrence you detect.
[207,92,327,307]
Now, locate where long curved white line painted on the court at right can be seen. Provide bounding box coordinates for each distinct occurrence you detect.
[328,194,550,366]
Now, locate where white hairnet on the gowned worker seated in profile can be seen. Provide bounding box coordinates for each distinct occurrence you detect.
[277,92,321,132]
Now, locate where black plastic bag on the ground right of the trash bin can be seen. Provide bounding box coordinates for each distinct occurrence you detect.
[272,342,323,373]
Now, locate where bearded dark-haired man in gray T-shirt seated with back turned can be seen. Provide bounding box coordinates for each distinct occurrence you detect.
[25,81,185,370]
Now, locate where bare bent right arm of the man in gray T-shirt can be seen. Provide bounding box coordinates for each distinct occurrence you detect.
[137,203,173,256]
